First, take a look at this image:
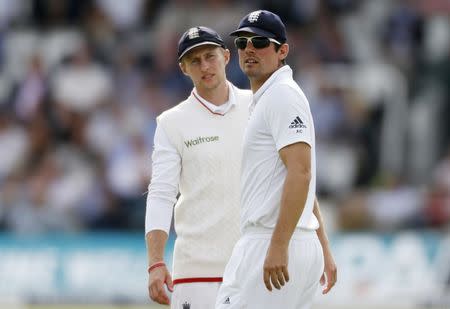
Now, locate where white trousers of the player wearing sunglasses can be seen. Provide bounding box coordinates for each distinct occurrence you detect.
[215,229,324,309]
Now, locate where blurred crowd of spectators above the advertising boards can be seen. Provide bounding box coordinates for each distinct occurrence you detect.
[0,0,450,233]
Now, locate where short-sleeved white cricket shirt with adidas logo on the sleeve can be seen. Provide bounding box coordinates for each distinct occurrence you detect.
[241,65,319,232]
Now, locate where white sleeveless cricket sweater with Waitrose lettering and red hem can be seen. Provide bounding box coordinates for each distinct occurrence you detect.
[157,86,252,282]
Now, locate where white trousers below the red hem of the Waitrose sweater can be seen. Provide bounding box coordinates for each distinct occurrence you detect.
[170,282,221,309]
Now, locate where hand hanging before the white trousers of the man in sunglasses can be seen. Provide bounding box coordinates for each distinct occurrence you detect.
[264,244,289,291]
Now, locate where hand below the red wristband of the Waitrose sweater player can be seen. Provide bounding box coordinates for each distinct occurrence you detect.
[148,266,173,305]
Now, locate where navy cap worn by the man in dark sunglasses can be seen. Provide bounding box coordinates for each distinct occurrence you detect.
[230,10,287,43]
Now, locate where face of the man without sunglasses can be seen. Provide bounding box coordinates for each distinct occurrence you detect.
[180,45,230,91]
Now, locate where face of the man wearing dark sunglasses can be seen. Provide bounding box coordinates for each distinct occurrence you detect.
[238,33,288,80]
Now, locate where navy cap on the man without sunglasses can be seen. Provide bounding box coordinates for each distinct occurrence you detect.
[178,26,226,61]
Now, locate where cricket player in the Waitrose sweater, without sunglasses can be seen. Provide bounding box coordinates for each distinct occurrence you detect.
[145,27,252,309]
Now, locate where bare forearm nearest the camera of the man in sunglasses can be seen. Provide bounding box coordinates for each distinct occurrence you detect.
[272,169,311,245]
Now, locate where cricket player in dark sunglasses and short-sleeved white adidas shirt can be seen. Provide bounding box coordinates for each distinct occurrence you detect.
[216,10,336,309]
